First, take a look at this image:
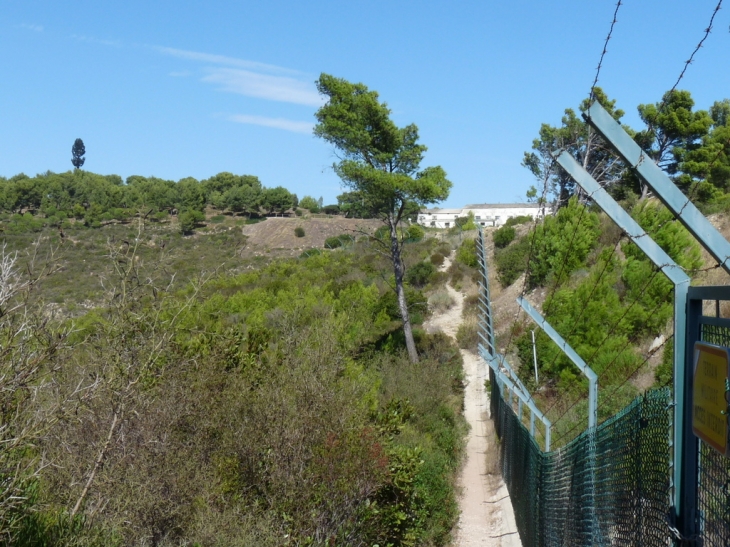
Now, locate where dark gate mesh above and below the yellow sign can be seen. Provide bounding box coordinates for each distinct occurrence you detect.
[697,324,730,547]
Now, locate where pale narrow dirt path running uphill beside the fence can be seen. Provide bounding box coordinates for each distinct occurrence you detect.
[425,261,521,547]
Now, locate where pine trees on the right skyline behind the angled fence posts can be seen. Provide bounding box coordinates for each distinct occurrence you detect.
[522,88,730,211]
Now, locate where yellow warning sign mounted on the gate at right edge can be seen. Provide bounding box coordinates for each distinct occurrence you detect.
[692,342,730,456]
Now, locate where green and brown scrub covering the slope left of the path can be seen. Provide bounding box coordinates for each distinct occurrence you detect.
[0,220,465,546]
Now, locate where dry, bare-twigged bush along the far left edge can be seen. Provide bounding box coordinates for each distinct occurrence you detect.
[0,242,73,542]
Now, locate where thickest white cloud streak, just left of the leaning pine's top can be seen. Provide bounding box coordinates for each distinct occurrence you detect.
[203,68,323,106]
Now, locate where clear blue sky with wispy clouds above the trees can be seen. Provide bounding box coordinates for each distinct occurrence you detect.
[0,0,730,207]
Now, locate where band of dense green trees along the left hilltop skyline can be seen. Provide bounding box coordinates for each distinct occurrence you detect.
[0,169,384,231]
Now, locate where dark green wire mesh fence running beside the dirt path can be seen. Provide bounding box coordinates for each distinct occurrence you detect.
[490,381,672,547]
